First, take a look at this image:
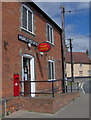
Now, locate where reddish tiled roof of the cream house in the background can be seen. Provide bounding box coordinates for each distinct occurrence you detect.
[65,52,91,63]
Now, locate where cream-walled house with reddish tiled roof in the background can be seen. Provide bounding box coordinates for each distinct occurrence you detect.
[66,52,91,78]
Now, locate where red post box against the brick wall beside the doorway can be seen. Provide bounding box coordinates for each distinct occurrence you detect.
[13,74,20,96]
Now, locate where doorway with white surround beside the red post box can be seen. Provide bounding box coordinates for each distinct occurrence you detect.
[21,54,35,97]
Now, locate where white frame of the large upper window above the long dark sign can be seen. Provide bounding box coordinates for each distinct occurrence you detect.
[21,4,35,35]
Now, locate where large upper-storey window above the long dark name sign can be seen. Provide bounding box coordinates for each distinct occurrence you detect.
[22,5,34,33]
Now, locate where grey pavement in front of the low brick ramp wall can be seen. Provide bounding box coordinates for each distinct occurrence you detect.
[6,92,89,118]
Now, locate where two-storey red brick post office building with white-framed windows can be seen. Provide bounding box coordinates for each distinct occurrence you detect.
[2,2,62,98]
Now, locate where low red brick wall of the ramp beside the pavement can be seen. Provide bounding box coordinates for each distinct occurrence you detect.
[4,92,80,113]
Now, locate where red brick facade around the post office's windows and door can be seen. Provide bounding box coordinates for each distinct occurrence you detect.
[2,2,62,97]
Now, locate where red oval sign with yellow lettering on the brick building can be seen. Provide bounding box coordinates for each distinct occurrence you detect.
[38,42,51,52]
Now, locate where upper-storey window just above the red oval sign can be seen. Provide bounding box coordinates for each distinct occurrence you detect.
[47,24,54,45]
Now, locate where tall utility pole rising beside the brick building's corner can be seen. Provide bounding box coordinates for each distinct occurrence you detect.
[61,6,66,93]
